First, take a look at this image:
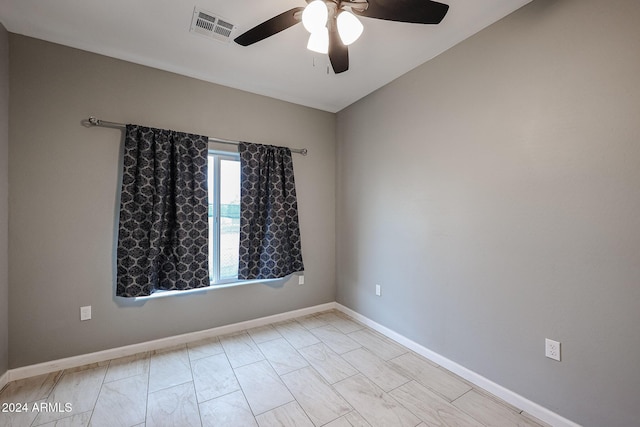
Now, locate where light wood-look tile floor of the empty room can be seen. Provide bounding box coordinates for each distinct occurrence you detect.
[0,311,544,427]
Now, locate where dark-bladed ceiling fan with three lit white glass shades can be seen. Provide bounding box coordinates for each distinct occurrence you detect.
[235,0,449,74]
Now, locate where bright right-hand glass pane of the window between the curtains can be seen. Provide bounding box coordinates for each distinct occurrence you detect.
[220,159,240,280]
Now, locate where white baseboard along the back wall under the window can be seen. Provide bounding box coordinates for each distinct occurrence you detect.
[7,302,336,389]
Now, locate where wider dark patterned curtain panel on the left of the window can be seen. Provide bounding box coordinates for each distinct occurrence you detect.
[116,125,209,297]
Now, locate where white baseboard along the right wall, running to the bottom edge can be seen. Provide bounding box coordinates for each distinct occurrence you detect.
[335,303,580,427]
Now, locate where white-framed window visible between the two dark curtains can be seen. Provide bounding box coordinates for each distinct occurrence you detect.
[208,151,240,285]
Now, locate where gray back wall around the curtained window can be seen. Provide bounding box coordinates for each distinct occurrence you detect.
[9,34,335,368]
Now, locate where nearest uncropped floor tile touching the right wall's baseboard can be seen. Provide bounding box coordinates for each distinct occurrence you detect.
[390,353,471,401]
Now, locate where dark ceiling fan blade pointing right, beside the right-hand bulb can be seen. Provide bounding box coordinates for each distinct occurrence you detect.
[353,0,449,24]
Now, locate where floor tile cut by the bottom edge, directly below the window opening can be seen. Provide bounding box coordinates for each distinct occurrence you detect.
[200,391,258,427]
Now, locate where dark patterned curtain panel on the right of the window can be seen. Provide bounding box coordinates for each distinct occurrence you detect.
[238,142,304,280]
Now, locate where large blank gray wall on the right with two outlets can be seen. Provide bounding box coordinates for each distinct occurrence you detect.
[337,0,640,427]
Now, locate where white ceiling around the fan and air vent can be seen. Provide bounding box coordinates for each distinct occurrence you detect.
[0,0,531,112]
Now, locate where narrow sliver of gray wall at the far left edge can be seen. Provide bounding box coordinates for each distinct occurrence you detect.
[0,24,9,376]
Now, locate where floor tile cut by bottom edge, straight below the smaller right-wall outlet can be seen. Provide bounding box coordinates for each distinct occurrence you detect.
[334,374,420,427]
